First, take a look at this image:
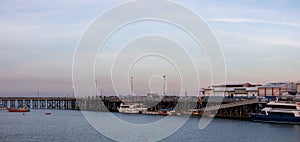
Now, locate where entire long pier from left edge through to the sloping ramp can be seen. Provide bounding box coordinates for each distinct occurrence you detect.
[0,96,266,119]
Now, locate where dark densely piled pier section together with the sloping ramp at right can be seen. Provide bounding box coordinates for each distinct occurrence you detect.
[77,96,266,119]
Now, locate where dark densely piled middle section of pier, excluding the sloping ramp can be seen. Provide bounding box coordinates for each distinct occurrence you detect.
[76,93,200,112]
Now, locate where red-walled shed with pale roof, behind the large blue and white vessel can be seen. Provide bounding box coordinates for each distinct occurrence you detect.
[258,82,297,99]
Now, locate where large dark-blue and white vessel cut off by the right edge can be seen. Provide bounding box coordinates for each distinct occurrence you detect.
[250,102,300,124]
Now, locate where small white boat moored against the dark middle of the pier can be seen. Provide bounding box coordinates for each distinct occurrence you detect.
[118,103,147,114]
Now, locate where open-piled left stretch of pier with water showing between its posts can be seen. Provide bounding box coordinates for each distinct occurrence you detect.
[0,97,77,109]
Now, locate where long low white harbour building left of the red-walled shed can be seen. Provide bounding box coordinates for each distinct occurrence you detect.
[200,82,261,98]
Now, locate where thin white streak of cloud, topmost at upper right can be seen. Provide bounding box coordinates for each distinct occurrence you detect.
[209,18,300,28]
